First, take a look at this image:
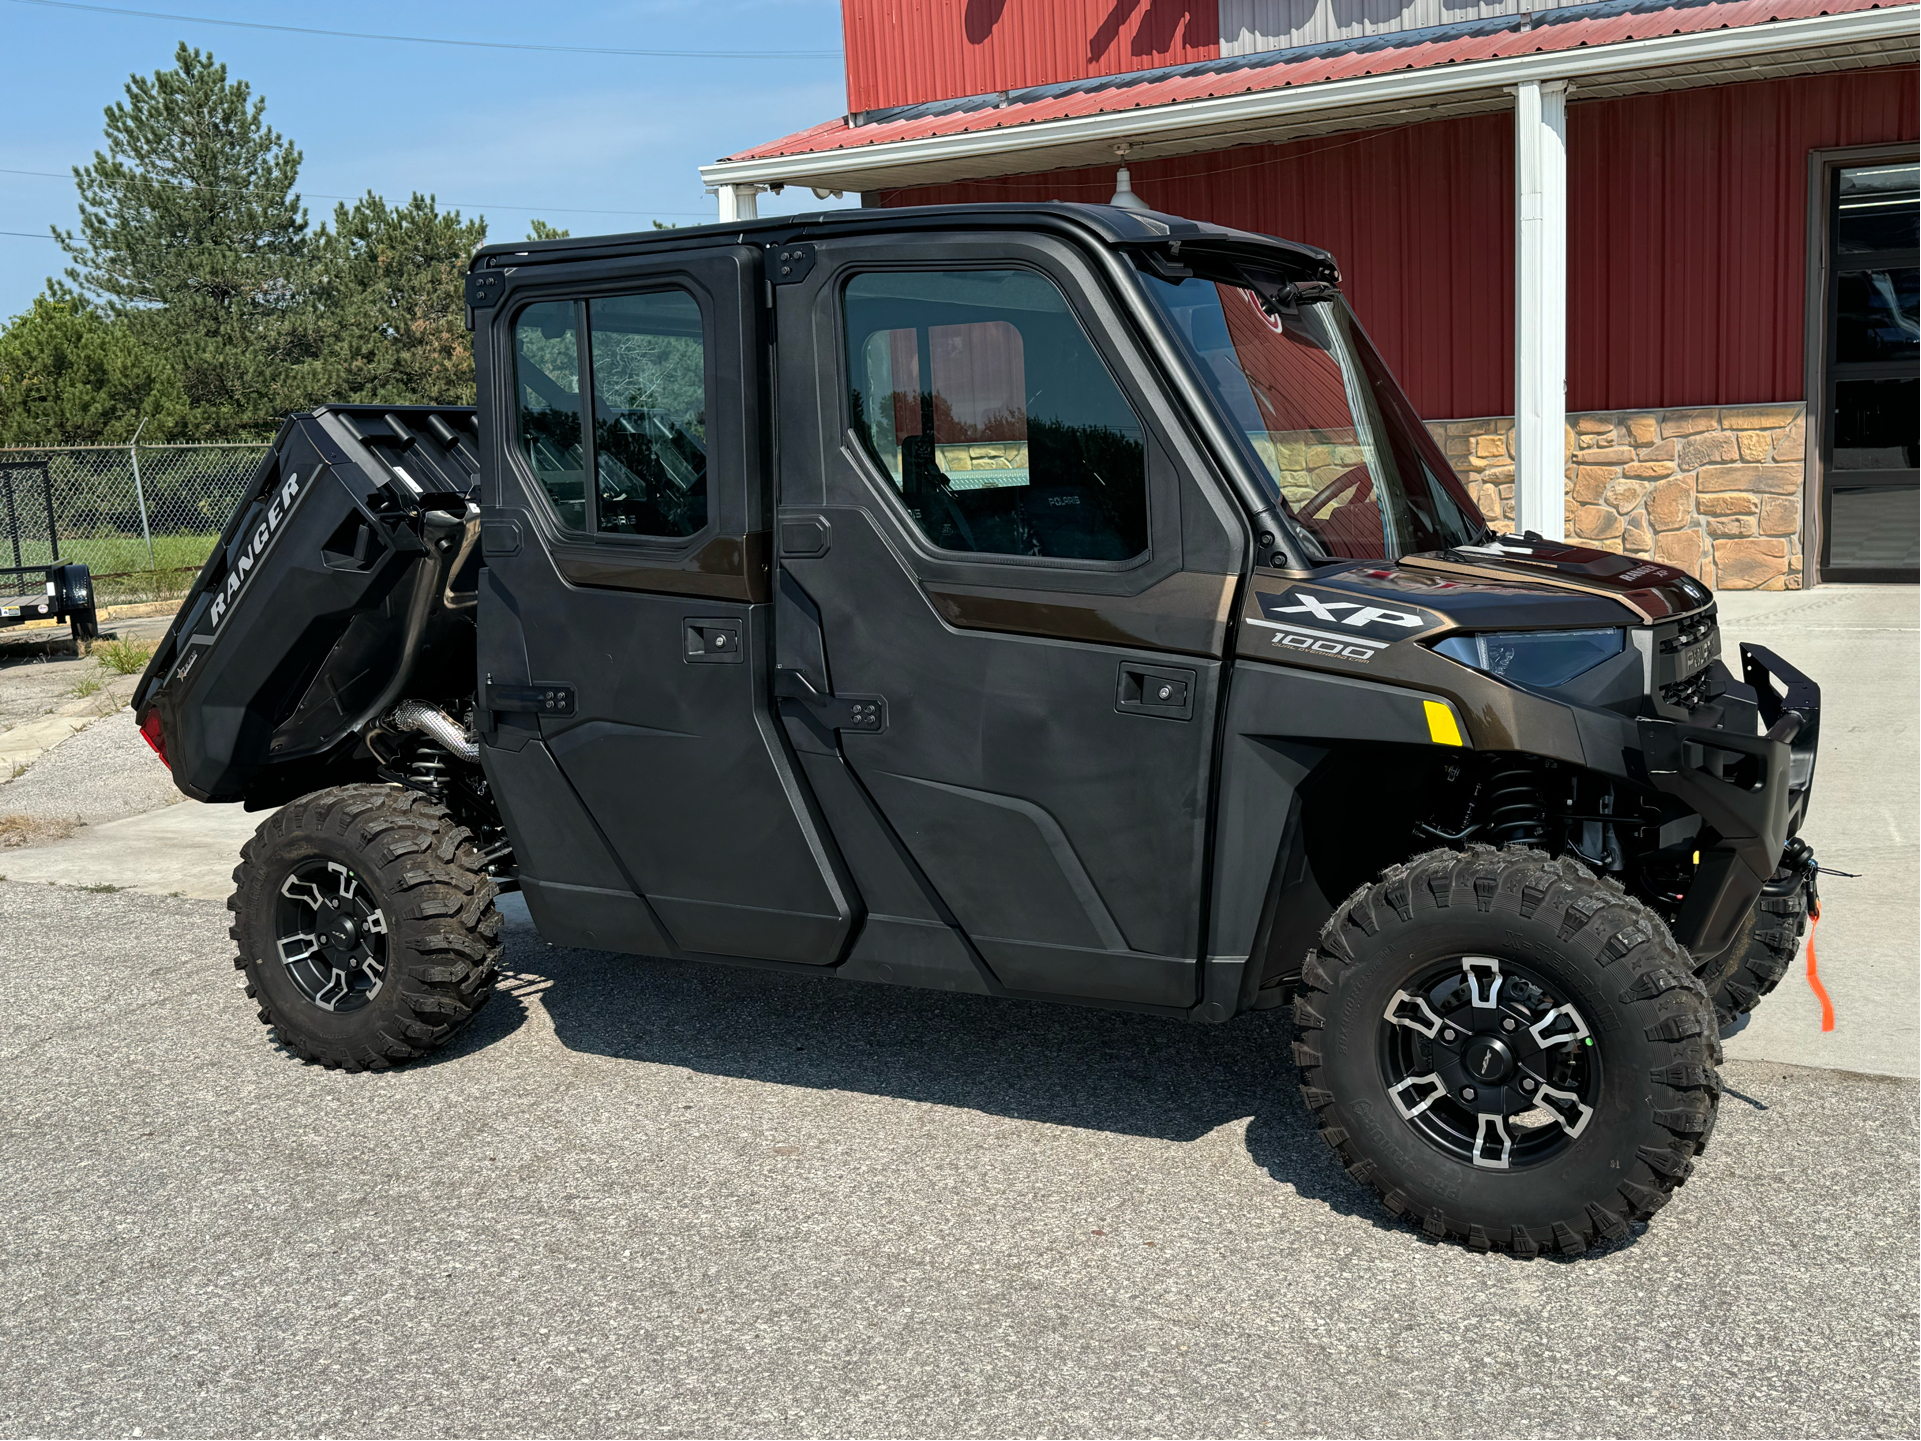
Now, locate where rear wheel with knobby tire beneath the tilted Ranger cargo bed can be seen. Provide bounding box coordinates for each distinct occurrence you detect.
[227,786,501,1070]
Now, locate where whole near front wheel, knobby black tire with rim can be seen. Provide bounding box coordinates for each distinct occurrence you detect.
[1295,845,1721,1257]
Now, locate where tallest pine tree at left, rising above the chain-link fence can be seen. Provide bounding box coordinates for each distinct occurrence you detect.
[54,42,317,438]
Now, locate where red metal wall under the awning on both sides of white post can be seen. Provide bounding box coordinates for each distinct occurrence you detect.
[870,69,1921,419]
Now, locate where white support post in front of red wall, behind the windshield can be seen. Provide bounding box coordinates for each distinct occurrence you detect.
[1514,81,1568,540]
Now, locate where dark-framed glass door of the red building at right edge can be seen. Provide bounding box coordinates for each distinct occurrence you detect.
[1821,161,1921,582]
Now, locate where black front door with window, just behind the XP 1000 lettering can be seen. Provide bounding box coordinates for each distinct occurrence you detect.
[776,236,1245,1007]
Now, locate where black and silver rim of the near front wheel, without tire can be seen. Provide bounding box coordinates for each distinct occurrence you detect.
[1381,955,1598,1170]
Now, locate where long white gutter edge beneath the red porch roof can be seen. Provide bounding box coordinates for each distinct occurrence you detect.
[701,4,1921,188]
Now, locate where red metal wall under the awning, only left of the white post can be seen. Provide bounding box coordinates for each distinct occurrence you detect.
[870,115,1514,417]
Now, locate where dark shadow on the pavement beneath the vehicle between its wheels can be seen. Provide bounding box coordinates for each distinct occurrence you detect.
[451,928,1395,1226]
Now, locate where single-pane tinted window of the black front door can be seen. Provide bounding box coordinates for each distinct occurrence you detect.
[843,271,1147,561]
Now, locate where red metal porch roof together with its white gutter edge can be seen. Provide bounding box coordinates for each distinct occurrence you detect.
[703,0,1917,190]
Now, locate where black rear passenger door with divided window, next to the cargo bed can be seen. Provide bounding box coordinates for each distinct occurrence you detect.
[476,248,855,965]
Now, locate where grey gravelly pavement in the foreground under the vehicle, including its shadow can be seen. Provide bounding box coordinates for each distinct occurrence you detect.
[0,884,1921,1437]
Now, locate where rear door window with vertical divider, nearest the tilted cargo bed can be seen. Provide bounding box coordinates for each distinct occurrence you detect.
[515,290,707,538]
